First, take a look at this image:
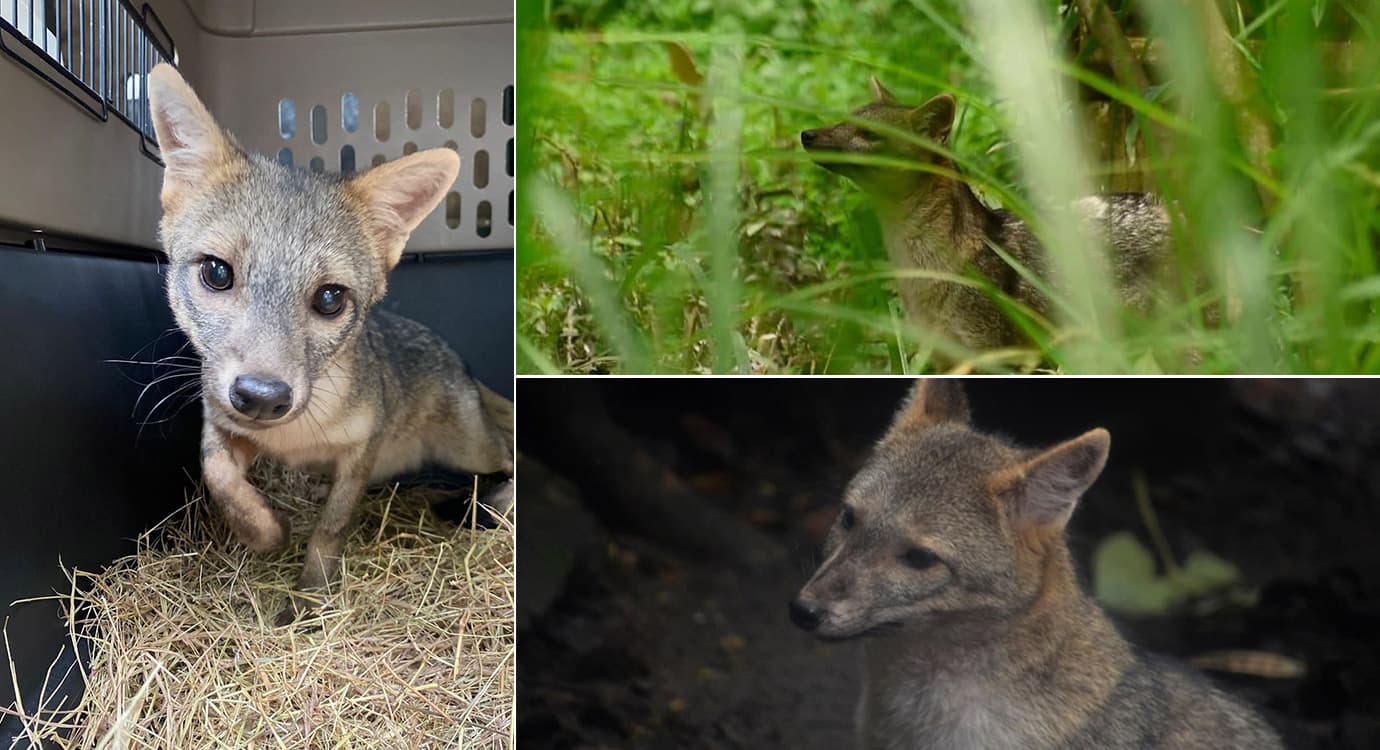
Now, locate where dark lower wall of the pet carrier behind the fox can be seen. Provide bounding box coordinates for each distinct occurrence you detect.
[0,236,513,746]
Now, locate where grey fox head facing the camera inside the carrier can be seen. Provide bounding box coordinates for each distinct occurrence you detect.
[149,64,460,430]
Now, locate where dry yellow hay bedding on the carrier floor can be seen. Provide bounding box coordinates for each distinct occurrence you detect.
[11,472,516,750]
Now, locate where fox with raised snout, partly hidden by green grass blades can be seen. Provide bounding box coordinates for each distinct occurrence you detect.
[800,77,1172,351]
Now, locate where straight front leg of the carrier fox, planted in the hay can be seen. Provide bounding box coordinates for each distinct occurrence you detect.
[277,450,374,626]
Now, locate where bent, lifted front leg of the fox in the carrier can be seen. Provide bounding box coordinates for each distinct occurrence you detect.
[201,421,290,552]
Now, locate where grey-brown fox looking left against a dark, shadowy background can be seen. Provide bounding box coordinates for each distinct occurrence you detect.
[788,378,1282,750]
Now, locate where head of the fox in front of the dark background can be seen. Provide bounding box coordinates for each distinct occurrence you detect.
[791,380,1111,640]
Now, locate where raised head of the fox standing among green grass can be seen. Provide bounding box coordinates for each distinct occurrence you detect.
[800,77,955,195]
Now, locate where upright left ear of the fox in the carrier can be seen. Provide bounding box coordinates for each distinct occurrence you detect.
[149,62,244,210]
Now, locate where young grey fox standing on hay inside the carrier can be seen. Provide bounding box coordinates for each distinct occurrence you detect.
[149,64,515,624]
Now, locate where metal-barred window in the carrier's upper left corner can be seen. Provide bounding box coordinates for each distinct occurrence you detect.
[0,0,177,162]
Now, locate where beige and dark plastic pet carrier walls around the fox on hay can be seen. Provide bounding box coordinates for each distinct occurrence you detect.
[0,0,513,747]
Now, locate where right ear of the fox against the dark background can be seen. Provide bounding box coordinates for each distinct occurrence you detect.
[989,427,1112,536]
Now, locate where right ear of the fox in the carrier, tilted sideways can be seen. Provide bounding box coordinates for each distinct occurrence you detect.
[346,148,460,268]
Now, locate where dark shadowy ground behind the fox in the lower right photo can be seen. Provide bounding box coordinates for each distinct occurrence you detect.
[518,378,1380,749]
